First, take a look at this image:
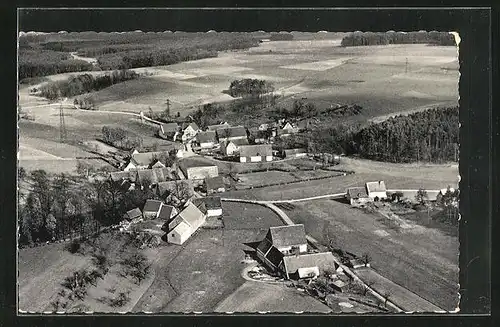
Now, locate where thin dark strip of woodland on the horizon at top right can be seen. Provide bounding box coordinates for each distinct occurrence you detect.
[341,31,456,47]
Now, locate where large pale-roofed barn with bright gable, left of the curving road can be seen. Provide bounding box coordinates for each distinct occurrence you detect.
[167,202,206,245]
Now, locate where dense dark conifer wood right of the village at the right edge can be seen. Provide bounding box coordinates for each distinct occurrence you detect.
[309,107,459,163]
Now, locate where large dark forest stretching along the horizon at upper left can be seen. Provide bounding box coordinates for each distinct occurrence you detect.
[19,32,258,80]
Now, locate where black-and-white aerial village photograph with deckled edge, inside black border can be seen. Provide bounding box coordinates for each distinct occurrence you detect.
[17,18,460,314]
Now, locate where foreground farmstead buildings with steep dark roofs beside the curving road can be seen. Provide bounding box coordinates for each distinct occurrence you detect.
[256,224,338,279]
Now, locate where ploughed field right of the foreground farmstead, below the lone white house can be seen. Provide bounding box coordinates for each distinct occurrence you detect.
[286,200,459,310]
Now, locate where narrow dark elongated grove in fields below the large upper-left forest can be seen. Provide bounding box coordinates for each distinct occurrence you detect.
[39,70,139,100]
